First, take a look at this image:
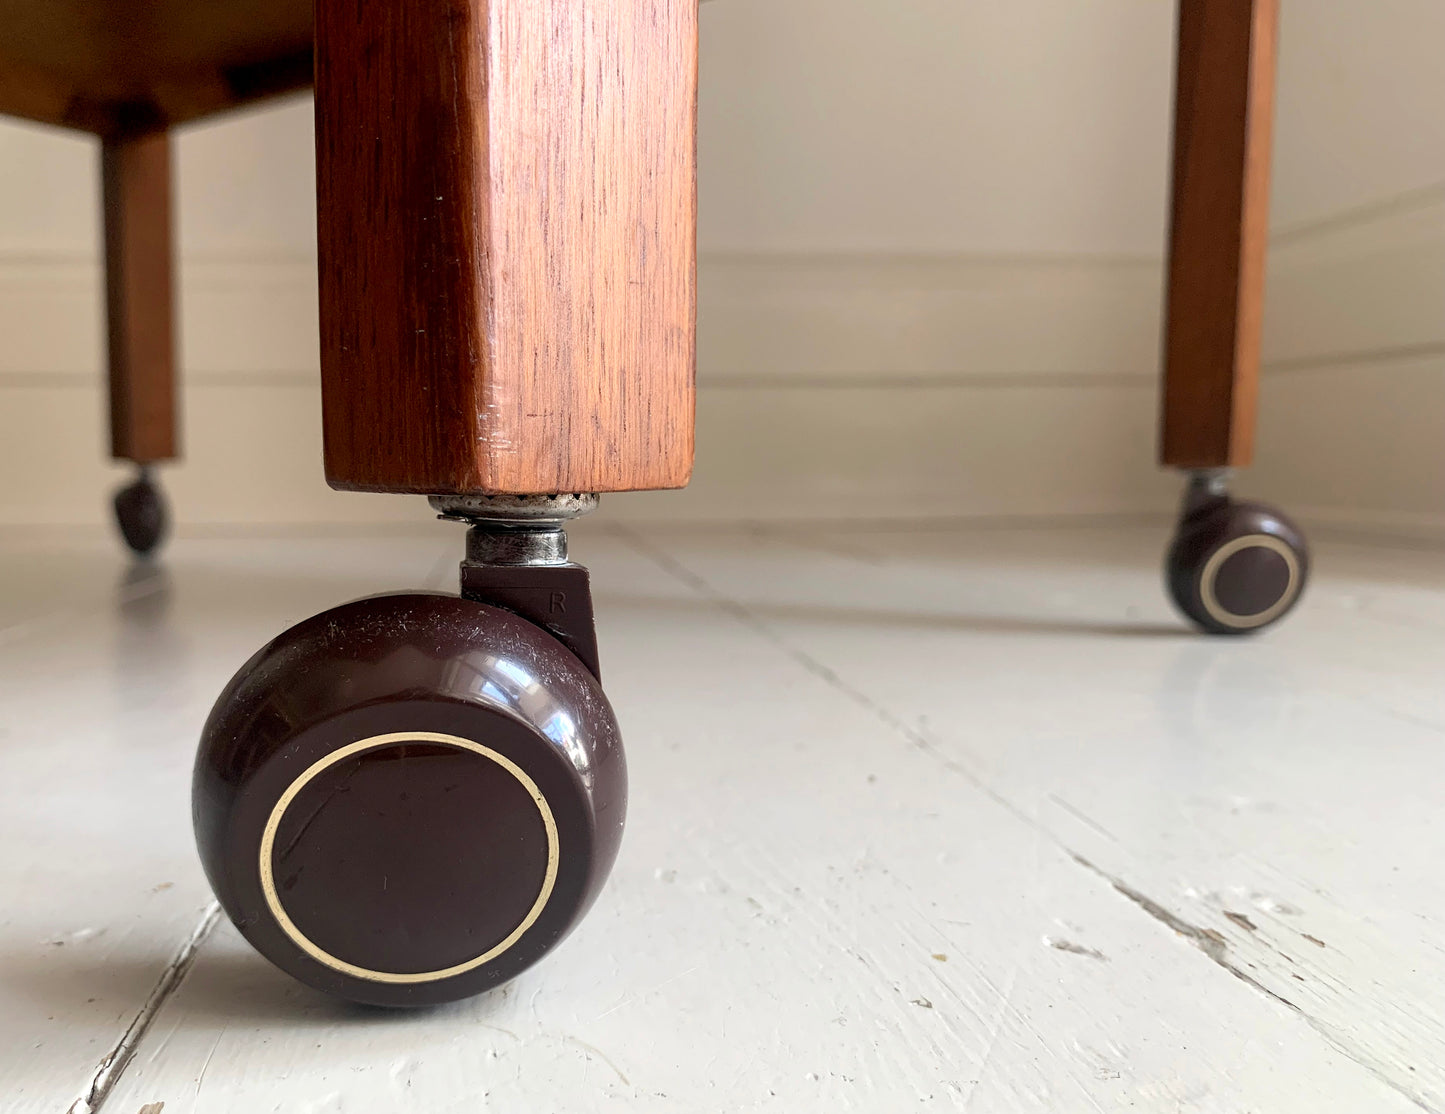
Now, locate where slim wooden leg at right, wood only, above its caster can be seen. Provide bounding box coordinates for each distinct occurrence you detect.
[1162,0,1279,468]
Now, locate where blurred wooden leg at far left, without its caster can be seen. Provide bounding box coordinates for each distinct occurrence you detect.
[101,133,176,464]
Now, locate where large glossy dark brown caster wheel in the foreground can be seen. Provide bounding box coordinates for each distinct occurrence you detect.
[192,583,626,1006]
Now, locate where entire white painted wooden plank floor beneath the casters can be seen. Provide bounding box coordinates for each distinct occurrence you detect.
[0,522,1445,1114]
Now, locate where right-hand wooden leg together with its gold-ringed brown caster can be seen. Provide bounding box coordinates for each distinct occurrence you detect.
[1160,0,1309,634]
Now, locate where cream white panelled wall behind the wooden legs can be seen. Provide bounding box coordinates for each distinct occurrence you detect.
[0,0,1445,532]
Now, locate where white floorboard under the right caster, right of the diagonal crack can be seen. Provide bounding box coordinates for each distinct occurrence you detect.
[649,529,1445,1110]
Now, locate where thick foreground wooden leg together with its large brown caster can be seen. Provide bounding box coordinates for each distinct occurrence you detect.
[192,0,696,1006]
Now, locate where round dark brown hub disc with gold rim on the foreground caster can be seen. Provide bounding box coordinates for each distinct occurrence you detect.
[260,731,559,983]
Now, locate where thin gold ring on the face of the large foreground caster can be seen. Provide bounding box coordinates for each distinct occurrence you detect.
[260,731,558,983]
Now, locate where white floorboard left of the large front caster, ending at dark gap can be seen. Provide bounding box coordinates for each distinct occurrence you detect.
[0,532,457,1114]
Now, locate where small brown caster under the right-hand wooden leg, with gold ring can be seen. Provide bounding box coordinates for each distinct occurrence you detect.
[1165,474,1309,634]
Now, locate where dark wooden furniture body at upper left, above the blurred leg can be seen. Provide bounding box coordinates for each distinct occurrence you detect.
[0,0,312,136]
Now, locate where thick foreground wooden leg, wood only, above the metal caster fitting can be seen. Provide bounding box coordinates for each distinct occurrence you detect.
[316,0,696,493]
